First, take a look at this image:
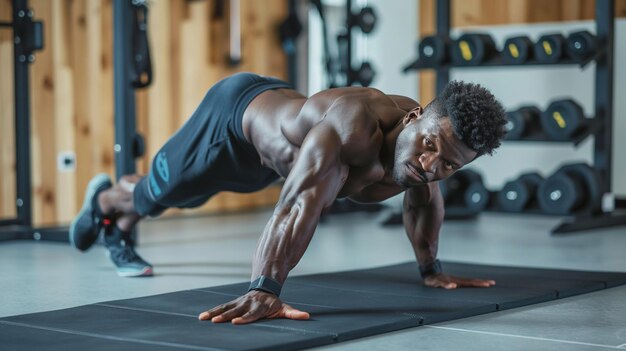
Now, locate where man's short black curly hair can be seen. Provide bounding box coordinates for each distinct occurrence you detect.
[424,81,506,157]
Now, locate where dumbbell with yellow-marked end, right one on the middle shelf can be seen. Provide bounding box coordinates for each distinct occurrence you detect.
[541,99,586,141]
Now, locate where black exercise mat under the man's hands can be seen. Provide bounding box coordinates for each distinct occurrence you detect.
[0,262,626,351]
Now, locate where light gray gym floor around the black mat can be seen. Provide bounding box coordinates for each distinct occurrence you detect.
[0,211,626,350]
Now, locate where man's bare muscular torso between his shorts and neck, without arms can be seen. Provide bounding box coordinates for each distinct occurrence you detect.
[243,87,417,201]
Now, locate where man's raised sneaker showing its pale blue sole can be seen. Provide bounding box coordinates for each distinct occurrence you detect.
[69,173,113,251]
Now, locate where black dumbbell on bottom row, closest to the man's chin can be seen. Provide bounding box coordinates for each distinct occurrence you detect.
[439,169,489,213]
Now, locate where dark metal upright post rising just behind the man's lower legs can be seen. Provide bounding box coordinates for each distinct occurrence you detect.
[113,0,136,179]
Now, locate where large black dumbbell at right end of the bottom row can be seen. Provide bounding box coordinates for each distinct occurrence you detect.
[537,163,604,215]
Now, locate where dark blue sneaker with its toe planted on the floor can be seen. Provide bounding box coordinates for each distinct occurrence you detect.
[104,225,154,277]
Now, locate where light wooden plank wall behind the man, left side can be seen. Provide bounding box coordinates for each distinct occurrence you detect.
[0,0,287,224]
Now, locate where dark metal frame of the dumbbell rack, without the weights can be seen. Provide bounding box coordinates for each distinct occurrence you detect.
[405,0,626,234]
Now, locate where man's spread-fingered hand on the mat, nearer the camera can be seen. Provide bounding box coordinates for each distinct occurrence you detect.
[198,290,309,324]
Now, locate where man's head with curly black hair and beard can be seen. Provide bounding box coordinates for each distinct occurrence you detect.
[393,81,506,187]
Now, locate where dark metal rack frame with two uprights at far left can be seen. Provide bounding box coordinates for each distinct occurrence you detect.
[0,0,140,242]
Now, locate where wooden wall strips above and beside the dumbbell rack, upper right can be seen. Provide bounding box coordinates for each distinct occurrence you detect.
[418,0,626,104]
